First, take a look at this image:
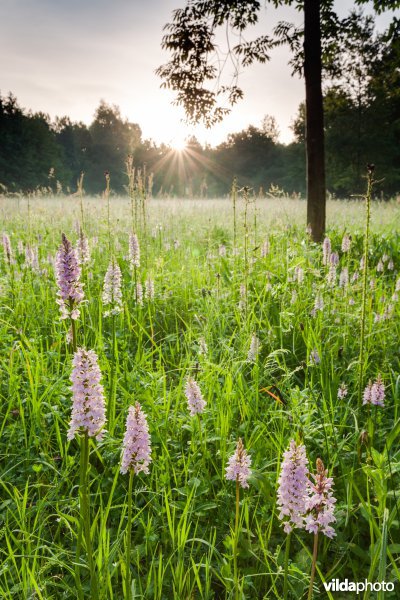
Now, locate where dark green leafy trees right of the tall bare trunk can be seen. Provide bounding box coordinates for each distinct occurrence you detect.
[286,13,400,198]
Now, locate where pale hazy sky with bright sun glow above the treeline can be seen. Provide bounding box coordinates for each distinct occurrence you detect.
[0,0,398,144]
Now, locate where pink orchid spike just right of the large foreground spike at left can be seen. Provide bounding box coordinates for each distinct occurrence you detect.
[121,402,151,475]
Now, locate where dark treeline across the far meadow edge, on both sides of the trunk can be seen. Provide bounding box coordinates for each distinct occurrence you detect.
[0,15,400,197]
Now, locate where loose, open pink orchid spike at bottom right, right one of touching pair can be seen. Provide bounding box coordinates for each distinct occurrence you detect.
[305,458,336,538]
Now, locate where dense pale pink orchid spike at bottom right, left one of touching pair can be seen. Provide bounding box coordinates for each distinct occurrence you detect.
[277,440,308,533]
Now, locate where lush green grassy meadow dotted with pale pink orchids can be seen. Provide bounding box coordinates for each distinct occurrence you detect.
[0,193,400,600]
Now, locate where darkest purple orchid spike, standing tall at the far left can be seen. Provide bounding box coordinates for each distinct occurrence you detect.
[56,234,84,319]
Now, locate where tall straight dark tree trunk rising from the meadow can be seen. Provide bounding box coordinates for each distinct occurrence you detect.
[304,0,326,242]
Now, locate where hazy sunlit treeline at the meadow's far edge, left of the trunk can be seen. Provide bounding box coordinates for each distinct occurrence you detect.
[0,95,304,196]
